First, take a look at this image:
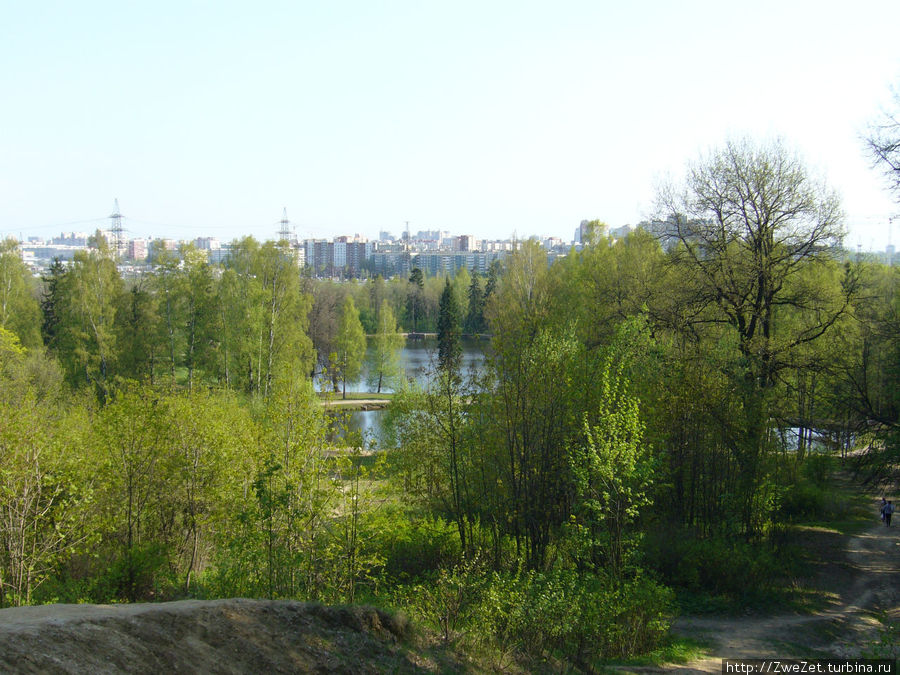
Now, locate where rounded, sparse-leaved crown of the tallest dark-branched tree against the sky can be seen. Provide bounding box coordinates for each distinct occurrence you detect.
[659,140,850,388]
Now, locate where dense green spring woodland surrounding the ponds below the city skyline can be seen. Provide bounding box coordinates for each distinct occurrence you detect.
[0,140,900,669]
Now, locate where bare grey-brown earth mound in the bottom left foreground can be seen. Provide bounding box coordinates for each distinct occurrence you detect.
[0,599,467,673]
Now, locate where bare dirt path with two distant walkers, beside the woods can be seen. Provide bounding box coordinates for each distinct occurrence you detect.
[660,508,900,673]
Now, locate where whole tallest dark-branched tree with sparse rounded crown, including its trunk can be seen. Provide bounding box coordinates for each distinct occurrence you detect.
[659,140,856,532]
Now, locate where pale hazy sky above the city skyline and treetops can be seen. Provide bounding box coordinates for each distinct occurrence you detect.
[0,0,900,248]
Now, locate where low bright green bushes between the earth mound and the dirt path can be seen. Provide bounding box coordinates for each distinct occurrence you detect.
[397,565,674,668]
